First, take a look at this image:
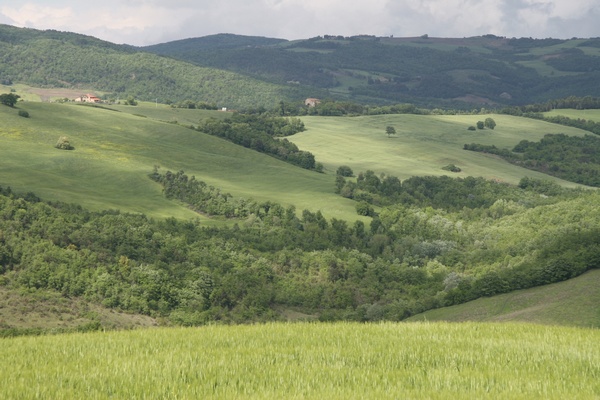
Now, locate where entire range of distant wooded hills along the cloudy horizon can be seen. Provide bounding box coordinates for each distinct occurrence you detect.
[0,25,600,109]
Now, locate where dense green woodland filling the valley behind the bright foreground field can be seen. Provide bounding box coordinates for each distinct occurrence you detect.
[0,171,600,325]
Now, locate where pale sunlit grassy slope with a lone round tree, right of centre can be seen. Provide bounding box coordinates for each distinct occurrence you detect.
[289,115,585,186]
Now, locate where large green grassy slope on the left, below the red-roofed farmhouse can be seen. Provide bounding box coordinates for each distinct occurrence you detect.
[0,102,355,219]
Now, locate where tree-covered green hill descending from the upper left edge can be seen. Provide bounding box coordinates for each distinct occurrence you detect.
[0,25,298,108]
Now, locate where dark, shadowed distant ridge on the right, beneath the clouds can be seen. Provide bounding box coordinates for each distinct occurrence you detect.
[144,35,600,108]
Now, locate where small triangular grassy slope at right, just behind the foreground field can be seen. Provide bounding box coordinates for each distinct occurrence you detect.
[408,270,600,328]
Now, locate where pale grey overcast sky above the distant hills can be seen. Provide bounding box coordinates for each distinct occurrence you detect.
[0,0,600,45]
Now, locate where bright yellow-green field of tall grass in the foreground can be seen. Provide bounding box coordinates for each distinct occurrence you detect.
[0,323,600,400]
